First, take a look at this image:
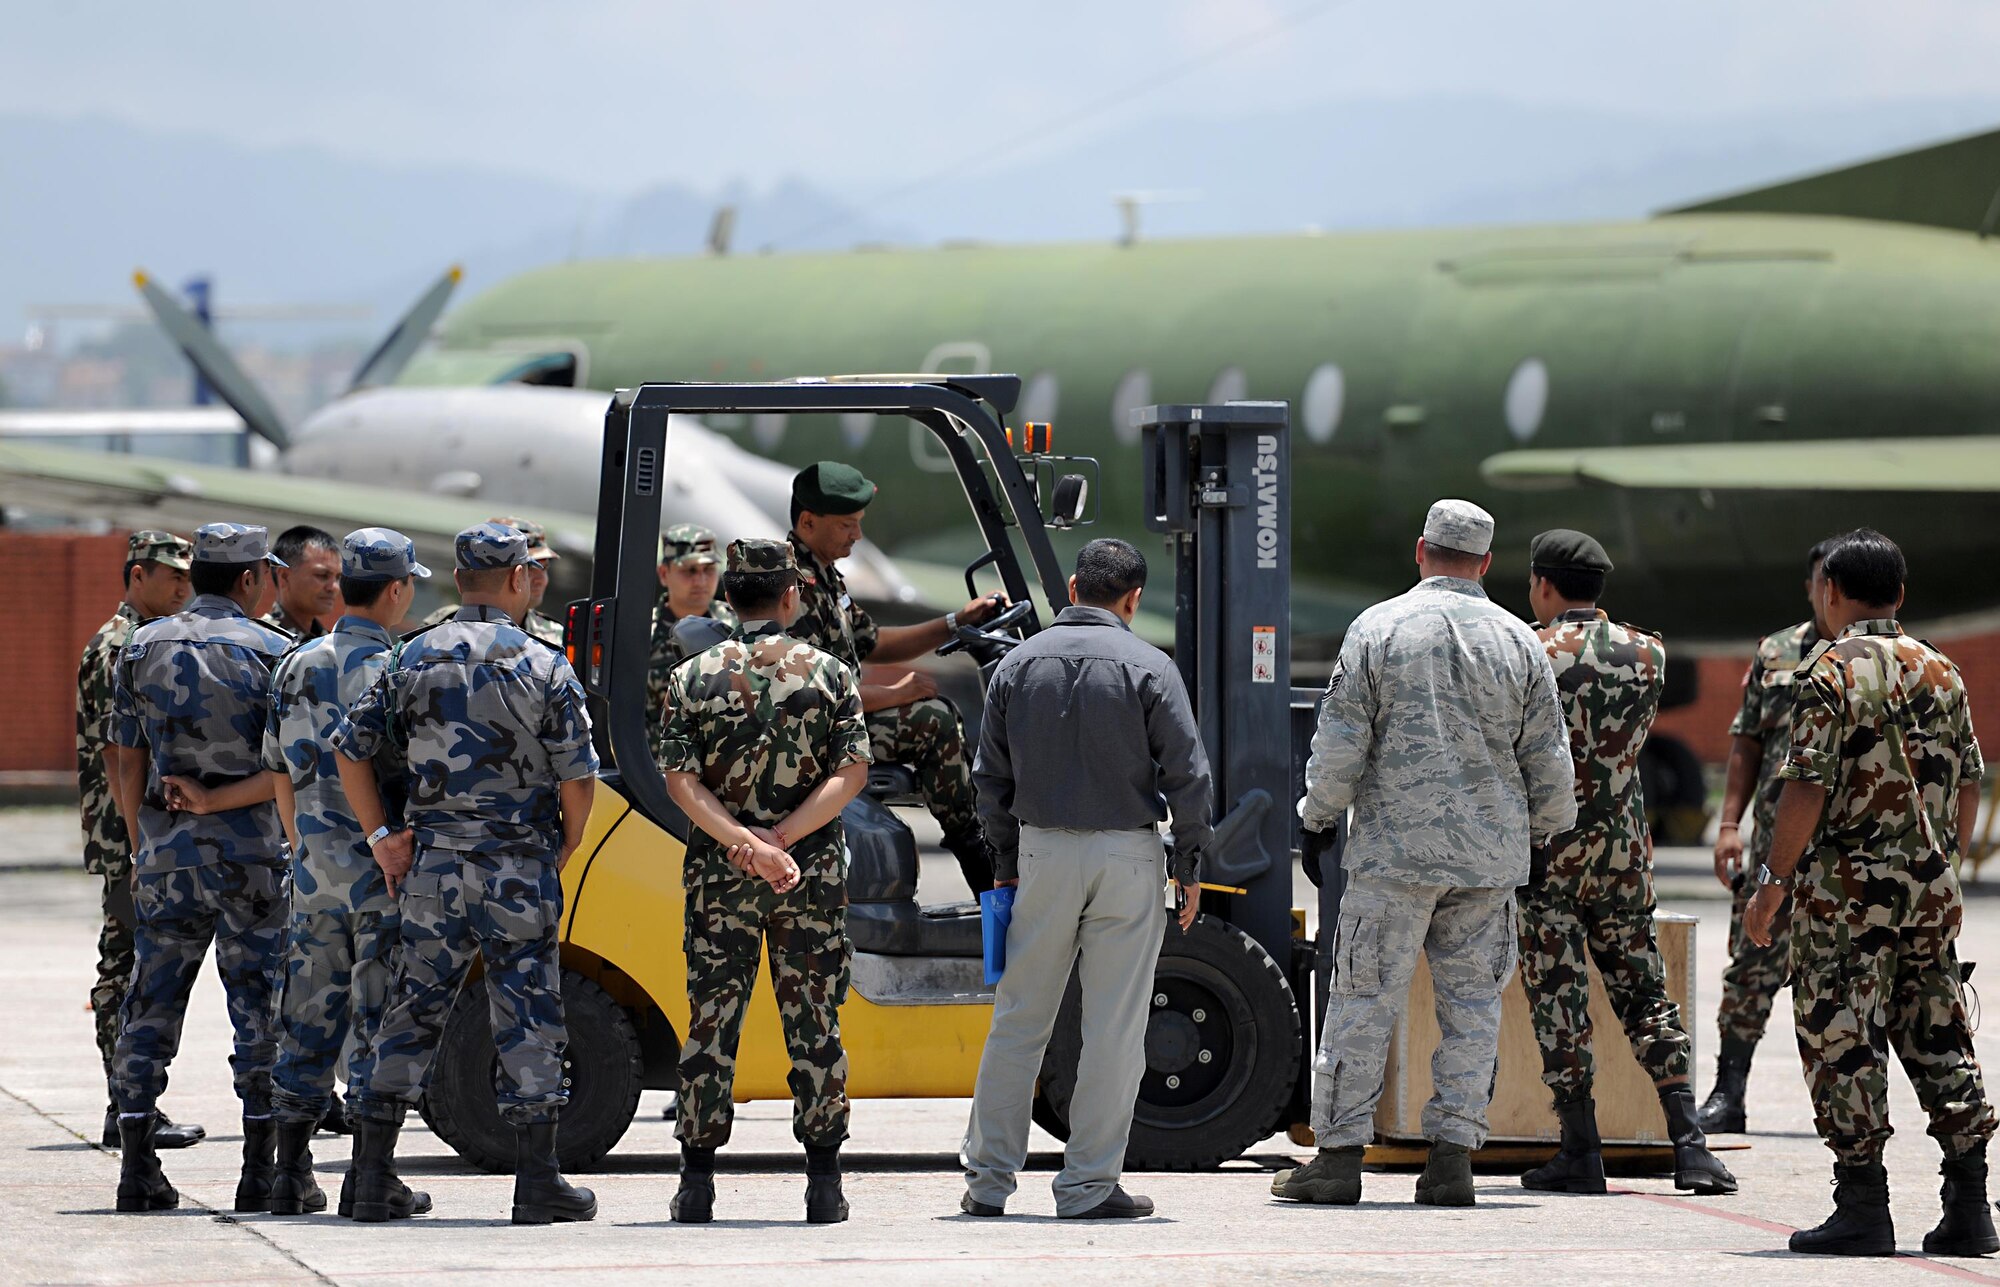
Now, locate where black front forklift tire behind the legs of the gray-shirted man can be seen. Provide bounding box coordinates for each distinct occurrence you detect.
[1034,915,1304,1171]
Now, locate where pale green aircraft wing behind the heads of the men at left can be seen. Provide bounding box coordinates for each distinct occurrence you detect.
[0,440,598,568]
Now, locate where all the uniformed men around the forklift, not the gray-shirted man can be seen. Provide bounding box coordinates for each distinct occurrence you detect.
[78,462,2000,1255]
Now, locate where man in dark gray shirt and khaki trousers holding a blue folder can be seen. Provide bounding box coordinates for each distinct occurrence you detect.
[960,540,1214,1219]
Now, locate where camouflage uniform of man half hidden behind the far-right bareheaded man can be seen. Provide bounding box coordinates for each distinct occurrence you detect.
[1716,622,1820,1057]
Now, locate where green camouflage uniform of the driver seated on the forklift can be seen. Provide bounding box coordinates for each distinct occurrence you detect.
[788,534,978,843]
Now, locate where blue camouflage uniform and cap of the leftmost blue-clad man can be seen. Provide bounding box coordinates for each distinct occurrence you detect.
[110,524,292,1117]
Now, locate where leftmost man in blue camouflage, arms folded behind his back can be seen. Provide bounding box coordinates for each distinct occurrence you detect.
[110,524,292,1211]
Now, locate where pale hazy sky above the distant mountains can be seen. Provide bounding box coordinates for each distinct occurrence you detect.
[0,0,2000,190]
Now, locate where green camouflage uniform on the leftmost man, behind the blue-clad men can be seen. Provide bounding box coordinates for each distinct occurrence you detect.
[76,604,140,1073]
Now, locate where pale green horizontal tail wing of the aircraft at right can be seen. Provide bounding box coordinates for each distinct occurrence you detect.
[1480,436,2000,492]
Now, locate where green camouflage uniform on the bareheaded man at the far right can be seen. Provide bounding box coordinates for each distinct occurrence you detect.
[1780,620,1994,1167]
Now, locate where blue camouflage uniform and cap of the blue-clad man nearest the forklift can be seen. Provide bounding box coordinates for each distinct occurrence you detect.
[334,524,598,1125]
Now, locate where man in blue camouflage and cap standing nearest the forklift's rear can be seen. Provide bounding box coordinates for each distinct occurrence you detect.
[334,524,598,1225]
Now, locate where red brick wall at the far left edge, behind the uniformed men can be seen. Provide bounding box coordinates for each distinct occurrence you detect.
[0,530,126,773]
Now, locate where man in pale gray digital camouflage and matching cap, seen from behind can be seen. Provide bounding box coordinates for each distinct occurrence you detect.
[1272,500,1576,1207]
